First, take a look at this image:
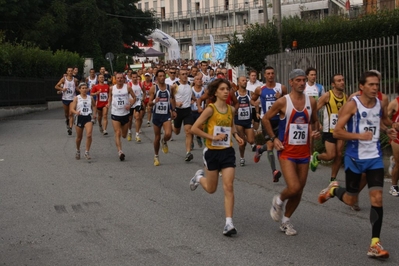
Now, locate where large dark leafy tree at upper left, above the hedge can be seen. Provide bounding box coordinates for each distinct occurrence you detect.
[0,0,158,58]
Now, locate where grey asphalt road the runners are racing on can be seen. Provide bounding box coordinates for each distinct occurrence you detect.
[0,109,399,266]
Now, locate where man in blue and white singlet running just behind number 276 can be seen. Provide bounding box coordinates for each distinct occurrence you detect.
[252,66,287,182]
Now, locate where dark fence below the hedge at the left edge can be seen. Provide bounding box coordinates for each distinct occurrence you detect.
[0,77,61,106]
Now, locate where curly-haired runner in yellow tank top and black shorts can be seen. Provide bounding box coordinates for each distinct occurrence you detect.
[190,79,244,236]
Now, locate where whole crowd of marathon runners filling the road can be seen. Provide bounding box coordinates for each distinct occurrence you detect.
[55,61,399,258]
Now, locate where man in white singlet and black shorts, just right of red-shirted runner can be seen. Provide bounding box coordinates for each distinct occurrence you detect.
[107,73,136,161]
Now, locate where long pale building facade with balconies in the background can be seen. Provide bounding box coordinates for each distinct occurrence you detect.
[136,0,398,59]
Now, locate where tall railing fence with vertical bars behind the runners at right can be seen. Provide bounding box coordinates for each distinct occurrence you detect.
[266,36,399,99]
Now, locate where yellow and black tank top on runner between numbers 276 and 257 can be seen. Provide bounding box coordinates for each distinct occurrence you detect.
[323,90,346,133]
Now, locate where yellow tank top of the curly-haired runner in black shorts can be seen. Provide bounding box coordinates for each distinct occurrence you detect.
[204,103,234,150]
